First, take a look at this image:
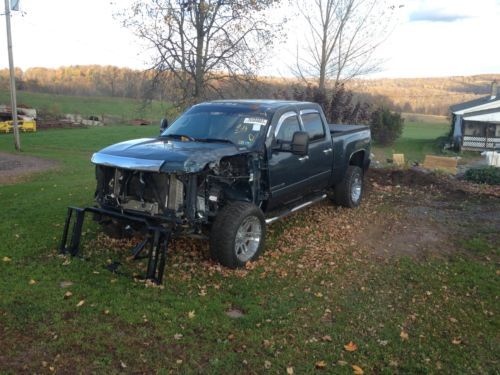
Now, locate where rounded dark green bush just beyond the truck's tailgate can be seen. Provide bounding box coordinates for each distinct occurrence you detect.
[370,107,404,146]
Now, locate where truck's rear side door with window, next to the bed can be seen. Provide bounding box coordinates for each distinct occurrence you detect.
[300,109,333,191]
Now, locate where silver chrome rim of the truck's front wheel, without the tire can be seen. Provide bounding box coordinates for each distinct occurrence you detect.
[234,216,262,262]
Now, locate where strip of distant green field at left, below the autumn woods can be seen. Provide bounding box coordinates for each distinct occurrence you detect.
[0,91,168,121]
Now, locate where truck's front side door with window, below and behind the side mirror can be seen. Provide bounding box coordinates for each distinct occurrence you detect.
[268,112,309,209]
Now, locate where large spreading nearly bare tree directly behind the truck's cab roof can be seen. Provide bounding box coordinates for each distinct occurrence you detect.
[120,0,278,104]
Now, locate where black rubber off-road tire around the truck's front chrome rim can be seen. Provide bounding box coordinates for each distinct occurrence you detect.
[210,202,266,268]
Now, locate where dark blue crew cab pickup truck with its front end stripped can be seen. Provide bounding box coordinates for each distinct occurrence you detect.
[92,100,370,268]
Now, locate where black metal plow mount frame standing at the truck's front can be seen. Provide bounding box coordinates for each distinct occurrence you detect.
[59,207,172,284]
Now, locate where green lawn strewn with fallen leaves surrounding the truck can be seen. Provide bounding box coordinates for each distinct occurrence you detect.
[0,125,500,374]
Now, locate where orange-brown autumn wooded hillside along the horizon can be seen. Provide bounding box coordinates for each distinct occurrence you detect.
[0,65,500,117]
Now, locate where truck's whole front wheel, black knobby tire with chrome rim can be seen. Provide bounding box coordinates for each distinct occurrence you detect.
[210,202,266,268]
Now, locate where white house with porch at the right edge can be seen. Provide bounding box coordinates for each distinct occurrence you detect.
[450,81,500,151]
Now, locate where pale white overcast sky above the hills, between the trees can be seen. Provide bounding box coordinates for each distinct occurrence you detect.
[0,0,500,77]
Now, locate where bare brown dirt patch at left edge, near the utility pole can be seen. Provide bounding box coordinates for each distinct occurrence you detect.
[0,152,57,185]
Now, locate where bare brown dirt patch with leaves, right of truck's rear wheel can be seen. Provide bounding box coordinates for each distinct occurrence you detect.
[358,170,500,257]
